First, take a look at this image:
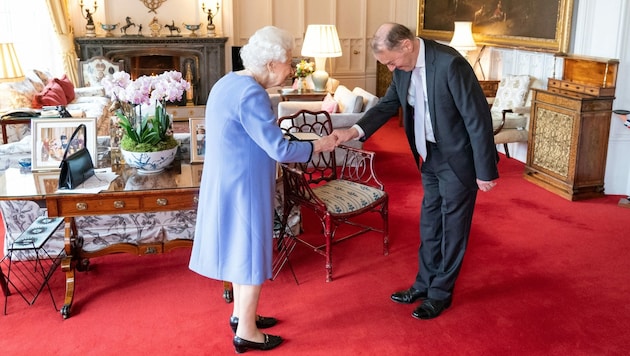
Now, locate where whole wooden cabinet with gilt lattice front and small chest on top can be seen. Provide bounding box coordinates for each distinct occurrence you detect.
[525,56,619,200]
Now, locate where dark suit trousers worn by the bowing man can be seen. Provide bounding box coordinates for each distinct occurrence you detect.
[413,143,477,300]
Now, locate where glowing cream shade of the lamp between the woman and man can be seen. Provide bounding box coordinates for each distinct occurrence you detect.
[302,25,341,58]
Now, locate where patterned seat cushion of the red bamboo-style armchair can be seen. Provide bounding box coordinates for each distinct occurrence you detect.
[313,179,385,214]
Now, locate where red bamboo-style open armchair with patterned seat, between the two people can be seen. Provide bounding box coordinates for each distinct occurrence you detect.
[278,110,389,282]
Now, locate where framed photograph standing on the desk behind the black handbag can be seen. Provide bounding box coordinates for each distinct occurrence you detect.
[31,117,97,172]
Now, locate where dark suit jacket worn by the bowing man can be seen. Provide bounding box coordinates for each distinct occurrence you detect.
[357,39,499,188]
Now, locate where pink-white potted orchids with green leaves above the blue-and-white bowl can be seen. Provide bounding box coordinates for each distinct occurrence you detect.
[101,71,190,152]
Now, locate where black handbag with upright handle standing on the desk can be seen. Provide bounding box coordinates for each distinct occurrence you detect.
[59,124,94,189]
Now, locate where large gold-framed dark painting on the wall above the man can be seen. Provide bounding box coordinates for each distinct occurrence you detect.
[418,0,574,53]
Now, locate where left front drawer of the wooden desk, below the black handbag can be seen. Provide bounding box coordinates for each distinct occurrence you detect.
[59,197,140,216]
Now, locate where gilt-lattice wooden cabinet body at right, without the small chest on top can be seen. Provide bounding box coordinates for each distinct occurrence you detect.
[524,89,614,200]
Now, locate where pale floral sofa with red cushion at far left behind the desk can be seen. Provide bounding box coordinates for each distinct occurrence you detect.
[0,70,111,143]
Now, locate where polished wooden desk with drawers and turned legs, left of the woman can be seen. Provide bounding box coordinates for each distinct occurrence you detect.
[0,161,232,319]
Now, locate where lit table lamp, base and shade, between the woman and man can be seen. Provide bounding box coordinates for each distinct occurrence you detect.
[302,25,341,91]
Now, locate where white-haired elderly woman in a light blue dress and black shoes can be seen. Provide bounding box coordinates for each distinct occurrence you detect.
[189,26,335,353]
